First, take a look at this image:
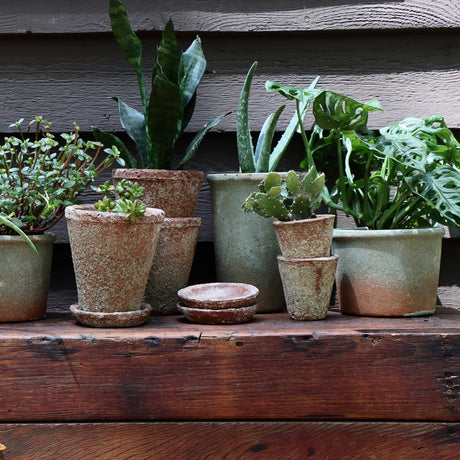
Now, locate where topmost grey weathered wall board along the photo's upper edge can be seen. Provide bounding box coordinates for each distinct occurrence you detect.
[0,0,460,34]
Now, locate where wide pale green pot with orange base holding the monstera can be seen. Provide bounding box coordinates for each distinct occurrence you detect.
[332,227,444,316]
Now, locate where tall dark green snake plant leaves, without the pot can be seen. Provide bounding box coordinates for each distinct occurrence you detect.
[93,0,228,169]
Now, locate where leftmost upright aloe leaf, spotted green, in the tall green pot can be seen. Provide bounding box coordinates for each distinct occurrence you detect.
[236,61,257,173]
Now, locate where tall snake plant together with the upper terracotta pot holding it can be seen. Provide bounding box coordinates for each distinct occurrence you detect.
[94,0,227,217]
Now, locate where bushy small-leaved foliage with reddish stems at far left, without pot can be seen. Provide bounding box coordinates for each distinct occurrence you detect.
[0,117,121,241]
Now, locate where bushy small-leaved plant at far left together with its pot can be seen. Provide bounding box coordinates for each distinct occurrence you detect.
[0,117,121,322]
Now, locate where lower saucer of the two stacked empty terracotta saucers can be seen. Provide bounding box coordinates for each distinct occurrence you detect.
[177,303,257,324]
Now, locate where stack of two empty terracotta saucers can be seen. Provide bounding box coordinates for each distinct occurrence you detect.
[177,283,259,324]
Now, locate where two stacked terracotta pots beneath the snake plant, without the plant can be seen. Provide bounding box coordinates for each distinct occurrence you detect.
[113,169,203,315]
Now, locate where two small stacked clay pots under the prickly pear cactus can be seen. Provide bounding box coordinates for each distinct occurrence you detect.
[273,215,338,320]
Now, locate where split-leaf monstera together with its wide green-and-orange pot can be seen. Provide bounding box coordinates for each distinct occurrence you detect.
[267,82,460,316]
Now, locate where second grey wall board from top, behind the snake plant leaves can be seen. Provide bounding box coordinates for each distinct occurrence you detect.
[0,32,460,133]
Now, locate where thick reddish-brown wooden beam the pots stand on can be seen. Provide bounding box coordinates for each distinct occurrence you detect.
[0,309,460,422]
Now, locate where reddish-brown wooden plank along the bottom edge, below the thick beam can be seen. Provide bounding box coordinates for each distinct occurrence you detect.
[0,422,460,460]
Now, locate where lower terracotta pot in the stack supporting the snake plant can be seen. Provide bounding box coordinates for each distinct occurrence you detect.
[144,217,201,315]
